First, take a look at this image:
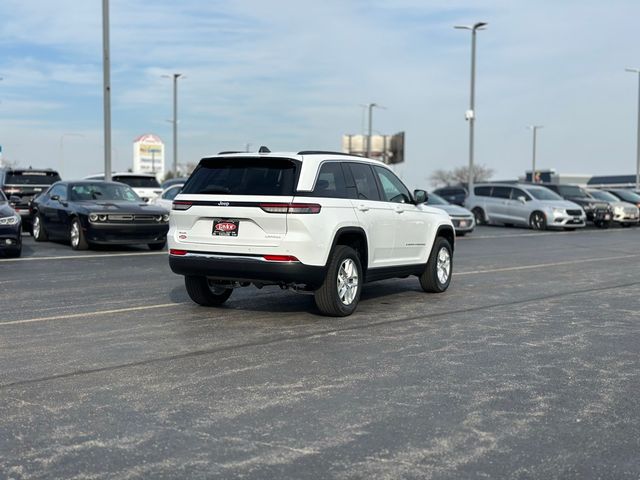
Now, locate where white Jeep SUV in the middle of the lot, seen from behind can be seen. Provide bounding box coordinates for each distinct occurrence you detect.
[167,147,455,316]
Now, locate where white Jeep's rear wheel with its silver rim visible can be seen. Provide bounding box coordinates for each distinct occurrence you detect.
[314,245,364,317]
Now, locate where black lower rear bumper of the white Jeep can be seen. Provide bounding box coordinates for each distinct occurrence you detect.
[169,252,326,288]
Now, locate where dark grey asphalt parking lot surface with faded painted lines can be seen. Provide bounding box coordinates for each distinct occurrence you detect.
[0,227,640,479]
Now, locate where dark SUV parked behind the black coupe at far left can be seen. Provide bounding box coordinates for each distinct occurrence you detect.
[0,167,60,231]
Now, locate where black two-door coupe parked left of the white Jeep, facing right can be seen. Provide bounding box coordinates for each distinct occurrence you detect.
[31,180,169,250]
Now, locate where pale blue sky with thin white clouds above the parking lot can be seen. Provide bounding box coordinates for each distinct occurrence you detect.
[0,0,640,187]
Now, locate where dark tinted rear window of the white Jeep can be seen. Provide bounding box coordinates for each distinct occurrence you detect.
[180,158,297,196]
